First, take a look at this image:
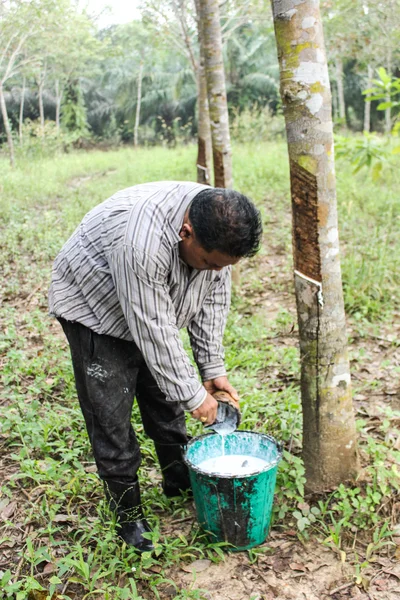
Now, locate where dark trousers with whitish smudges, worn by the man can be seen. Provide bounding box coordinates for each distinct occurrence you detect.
[58,318,187,483]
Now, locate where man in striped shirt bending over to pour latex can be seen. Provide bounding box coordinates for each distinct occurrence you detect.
[49,182,261,551]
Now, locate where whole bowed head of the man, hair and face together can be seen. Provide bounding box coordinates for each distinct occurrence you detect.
[179,188,262,271]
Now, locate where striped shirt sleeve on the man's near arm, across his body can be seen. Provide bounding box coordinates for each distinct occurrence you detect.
[108,246,207,411]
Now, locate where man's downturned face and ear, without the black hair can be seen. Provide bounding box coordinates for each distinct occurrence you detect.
[179,223,240,271]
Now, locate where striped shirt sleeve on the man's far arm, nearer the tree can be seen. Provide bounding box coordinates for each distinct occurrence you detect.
[188,267,231,381]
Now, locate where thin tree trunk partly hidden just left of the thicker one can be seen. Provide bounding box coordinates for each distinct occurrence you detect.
[195,0,212,185]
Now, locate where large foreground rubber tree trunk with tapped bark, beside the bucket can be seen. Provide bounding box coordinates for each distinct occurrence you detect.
[271,0,358,491]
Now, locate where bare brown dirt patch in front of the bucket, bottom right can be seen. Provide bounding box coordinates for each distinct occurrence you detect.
[164,531,400,600]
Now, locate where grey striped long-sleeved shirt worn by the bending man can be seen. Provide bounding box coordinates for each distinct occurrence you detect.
[49,181,231,411]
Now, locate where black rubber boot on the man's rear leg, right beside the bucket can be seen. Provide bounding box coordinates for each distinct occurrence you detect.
[154,442,191,498]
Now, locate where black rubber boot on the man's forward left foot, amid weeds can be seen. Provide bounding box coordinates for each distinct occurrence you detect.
[104,479,154,552]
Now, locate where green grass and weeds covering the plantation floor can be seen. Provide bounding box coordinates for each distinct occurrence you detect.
[0,143,400,600]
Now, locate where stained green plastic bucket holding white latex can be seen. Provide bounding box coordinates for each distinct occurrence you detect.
[185,431,282,550]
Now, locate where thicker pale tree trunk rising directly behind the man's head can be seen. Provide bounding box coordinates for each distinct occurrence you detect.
[199,0,232,188]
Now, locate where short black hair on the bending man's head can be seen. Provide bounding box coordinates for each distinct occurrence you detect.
[189,187,262,258]
